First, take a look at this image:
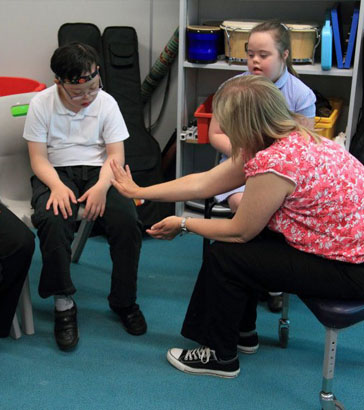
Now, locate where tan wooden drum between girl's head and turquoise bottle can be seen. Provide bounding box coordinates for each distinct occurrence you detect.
[285,23,320,64]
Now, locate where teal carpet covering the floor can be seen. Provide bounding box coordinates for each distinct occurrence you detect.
[0,235,364,410]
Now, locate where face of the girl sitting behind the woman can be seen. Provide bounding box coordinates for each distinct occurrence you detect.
[247,32,288,82]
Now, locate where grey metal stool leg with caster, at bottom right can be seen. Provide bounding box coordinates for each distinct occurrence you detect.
[320,328,344,410]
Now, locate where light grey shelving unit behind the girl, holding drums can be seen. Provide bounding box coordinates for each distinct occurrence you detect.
[176,0,364,215]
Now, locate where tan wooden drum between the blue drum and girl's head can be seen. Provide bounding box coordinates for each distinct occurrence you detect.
[220,20,259,63]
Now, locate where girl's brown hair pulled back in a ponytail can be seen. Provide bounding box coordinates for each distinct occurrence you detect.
[249,20,298,77]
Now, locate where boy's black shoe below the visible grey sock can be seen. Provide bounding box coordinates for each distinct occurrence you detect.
[54,302,79,351]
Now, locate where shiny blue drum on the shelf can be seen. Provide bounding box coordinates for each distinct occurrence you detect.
[186,26,220,64]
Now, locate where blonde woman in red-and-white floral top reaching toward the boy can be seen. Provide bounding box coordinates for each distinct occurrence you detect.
[111,76,364,377]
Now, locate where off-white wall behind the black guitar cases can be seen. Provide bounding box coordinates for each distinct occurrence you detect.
[0,0,179,148]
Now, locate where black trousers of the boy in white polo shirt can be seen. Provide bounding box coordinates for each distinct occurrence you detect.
[32,166,142,309]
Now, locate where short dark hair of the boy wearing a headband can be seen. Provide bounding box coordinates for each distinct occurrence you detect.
[51,42,99,81]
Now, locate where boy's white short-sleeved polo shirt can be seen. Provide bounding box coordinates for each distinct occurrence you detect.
[23,85,129,167]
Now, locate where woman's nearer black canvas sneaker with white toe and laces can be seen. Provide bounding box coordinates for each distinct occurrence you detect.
[167,346,240,378]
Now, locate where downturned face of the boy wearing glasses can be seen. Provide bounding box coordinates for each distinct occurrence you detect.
[57,67,101,112]
